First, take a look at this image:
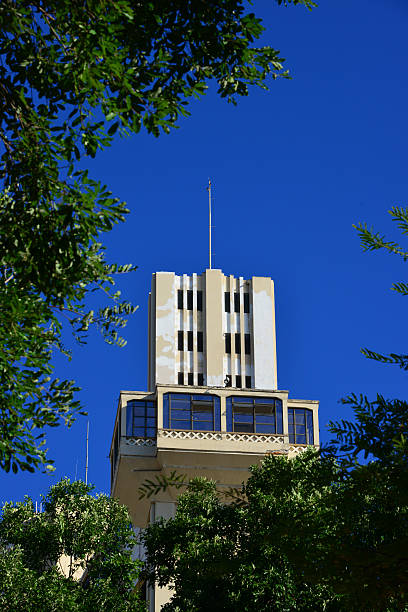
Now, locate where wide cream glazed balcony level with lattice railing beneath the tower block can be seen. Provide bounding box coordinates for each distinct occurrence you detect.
[110,385,319,487]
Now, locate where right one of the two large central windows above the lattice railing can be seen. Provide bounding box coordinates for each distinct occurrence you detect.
[227,396,283,434]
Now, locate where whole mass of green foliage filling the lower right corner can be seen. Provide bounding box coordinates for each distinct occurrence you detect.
[144,449,408,612]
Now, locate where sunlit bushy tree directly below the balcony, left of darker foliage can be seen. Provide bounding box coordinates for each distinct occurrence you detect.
[143,451,347,612]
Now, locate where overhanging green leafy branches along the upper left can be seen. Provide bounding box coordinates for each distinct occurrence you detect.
[0,0,313,471]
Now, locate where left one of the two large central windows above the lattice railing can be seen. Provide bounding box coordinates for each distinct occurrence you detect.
[165,393,220,431]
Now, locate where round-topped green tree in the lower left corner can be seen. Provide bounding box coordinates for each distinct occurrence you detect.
[0,480,145,612]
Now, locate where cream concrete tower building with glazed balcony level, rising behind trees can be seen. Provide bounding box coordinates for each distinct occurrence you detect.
[110,269,319,612]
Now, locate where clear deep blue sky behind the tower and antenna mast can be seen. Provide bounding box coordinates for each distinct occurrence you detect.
[0,0,408,501]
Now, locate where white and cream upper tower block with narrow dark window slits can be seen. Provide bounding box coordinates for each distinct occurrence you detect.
[148,270,278,390]
